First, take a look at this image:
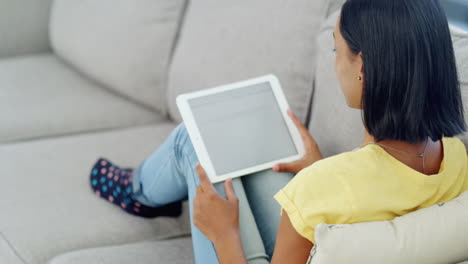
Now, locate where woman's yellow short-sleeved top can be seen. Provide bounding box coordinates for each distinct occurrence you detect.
[274,137,468,244]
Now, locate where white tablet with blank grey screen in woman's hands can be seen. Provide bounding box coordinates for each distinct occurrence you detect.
[177,75,304,183]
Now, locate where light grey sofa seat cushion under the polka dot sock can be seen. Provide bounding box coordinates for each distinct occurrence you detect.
[0,123,190,264]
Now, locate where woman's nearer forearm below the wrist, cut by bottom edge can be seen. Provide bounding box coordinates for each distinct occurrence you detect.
[214,230,247,264]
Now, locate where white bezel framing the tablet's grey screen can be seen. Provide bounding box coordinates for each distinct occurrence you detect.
[176,74,305,183]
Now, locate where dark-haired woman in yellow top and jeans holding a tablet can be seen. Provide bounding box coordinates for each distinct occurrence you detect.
[91,0,468,263]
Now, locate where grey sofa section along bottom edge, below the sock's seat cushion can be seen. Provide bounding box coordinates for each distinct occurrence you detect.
[48,237,194,264]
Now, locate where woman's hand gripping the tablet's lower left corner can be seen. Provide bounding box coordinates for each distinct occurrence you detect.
[193,164,239,244]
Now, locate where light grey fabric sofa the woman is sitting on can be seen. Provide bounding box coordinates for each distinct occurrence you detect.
[0,0,468,264]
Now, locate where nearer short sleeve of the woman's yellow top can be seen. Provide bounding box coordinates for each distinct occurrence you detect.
[274,162,353,244]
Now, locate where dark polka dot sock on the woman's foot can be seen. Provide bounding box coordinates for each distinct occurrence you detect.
[90,158,182,218]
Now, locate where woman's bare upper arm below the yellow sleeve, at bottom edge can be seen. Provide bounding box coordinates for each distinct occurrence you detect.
[271,210,314,264]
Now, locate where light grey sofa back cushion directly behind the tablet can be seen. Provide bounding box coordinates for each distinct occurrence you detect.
[168,0,326,124]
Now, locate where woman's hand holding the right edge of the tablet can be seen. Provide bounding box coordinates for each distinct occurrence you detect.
[273,110,323,174]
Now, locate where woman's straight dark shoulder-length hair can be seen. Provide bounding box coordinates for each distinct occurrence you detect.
[340,0,466,143]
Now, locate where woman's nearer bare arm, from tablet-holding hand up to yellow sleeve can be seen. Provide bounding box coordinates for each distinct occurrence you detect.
[193,165,313,264]
